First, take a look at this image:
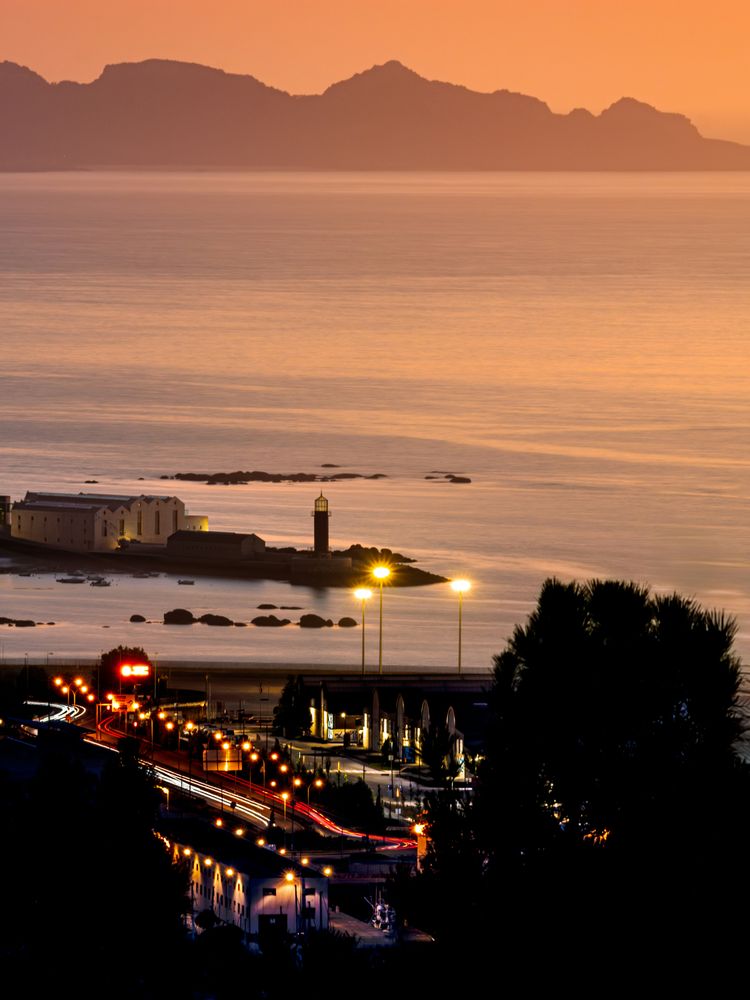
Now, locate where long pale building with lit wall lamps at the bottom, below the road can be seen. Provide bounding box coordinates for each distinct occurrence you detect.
[160,820,329,944]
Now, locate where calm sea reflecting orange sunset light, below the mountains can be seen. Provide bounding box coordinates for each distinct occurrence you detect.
[0,173,750,670]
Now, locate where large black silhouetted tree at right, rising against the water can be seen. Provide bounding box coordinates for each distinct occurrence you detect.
[471,580,750,976]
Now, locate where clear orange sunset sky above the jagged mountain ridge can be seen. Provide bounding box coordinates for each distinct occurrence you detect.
[5,0,750,143]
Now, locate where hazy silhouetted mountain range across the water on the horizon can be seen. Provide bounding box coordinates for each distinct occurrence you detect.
[0,59,750,171]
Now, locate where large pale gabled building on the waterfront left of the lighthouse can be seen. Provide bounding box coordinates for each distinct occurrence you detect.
[10,491,208,552]
